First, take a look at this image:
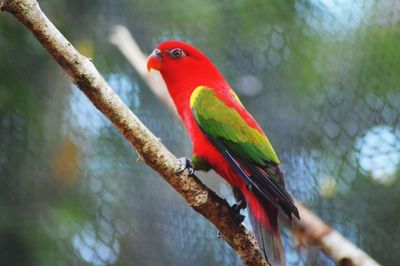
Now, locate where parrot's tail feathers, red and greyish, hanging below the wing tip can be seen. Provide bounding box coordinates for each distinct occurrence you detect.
[248,194,286,266]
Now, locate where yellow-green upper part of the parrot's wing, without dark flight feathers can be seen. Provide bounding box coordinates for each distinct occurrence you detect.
[190,86,279,166]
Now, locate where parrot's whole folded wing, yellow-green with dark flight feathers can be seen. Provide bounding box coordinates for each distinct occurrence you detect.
[190,86,299,219]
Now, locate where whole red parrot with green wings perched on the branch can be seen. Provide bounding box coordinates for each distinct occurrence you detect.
[147,40,300,266]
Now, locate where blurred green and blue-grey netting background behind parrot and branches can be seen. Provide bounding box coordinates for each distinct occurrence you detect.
[0,0,400,266]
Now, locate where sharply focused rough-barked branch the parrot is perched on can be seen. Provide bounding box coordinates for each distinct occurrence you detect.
[0,0,267,265]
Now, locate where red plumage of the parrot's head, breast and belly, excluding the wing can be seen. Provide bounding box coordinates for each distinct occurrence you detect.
[148,41,298,265]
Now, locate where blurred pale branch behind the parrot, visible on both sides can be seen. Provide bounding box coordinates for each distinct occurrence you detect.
[110,26,379,266]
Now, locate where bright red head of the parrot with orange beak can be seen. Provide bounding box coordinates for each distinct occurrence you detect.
[147,40,223,95]
